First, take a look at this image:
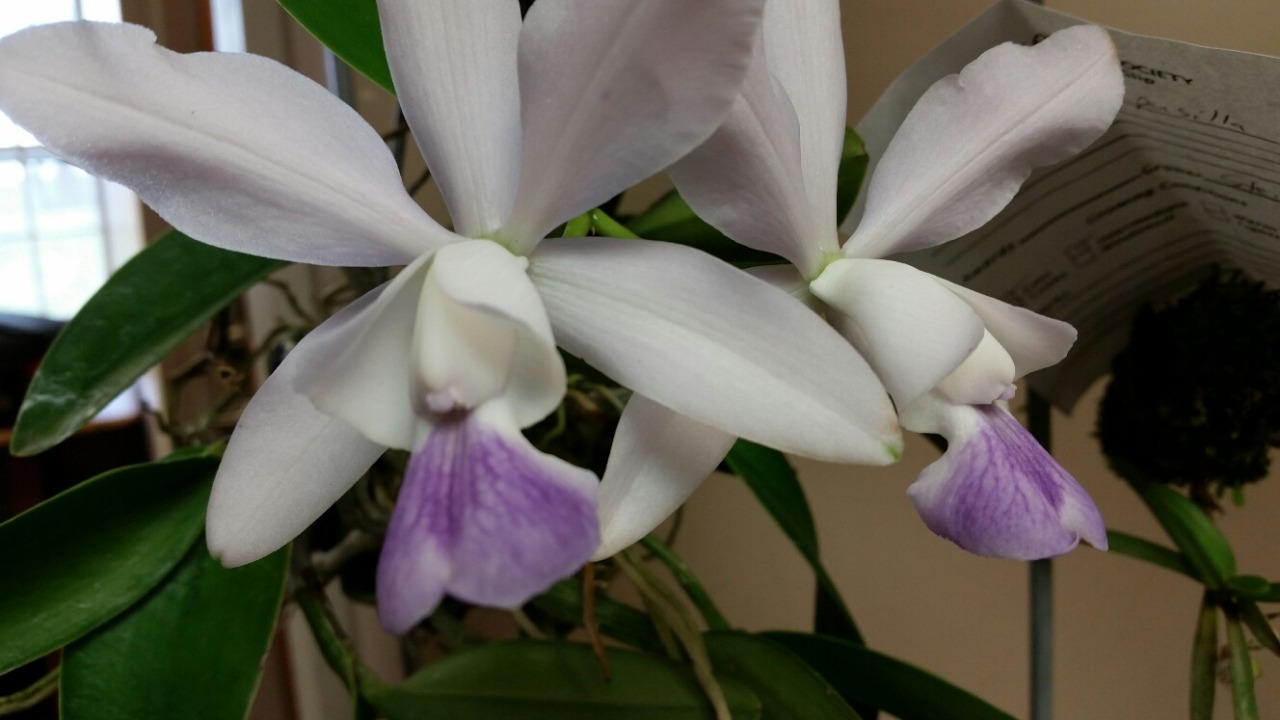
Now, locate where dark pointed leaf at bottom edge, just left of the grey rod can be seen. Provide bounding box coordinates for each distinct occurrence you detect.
[765,633,1014,720]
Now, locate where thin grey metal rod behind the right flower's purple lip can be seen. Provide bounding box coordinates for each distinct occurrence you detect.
[1027,392,1053,720]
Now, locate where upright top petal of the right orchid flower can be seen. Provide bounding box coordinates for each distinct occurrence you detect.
[764,0,847,229]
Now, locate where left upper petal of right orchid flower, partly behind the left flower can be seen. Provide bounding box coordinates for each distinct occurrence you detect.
[667,44,838,272]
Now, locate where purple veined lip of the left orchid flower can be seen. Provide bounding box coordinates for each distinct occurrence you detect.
[378,413,599,633]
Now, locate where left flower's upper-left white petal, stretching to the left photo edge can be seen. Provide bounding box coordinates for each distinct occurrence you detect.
[0,23,449,265]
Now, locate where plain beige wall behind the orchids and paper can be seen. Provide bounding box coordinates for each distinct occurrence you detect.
[677,0,1280,720]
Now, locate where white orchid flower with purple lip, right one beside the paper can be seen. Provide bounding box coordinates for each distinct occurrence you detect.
[602,0,1124,559]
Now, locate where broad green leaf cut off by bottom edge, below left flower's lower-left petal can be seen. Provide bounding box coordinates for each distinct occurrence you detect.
[60,543,289,720]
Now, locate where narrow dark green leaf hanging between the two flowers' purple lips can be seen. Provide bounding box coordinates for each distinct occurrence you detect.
[724,439,863,643]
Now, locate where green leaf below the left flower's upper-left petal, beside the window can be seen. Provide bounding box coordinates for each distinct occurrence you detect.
[13,231,283,455]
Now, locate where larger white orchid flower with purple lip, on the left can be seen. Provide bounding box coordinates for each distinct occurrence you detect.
[0,0,901,632]
